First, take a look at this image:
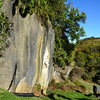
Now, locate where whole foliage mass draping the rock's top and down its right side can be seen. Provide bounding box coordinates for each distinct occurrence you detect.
[1,0,86,67]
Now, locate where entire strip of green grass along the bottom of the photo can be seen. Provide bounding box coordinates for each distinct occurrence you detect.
[0,89,99,100]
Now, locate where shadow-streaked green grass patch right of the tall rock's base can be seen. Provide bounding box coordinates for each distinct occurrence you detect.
[53,90,97,100]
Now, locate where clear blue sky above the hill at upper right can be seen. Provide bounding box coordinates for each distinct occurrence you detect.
[71,0,100,37]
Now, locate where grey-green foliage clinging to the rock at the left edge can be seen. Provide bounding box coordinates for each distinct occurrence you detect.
[0,0,10,55]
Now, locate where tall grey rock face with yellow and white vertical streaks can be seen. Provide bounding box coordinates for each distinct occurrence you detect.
[0,0,54,93]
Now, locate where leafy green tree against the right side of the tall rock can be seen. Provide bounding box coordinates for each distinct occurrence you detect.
[54,2,86,66]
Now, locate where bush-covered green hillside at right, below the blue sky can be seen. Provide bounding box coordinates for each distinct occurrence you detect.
[75,38,100,83]
